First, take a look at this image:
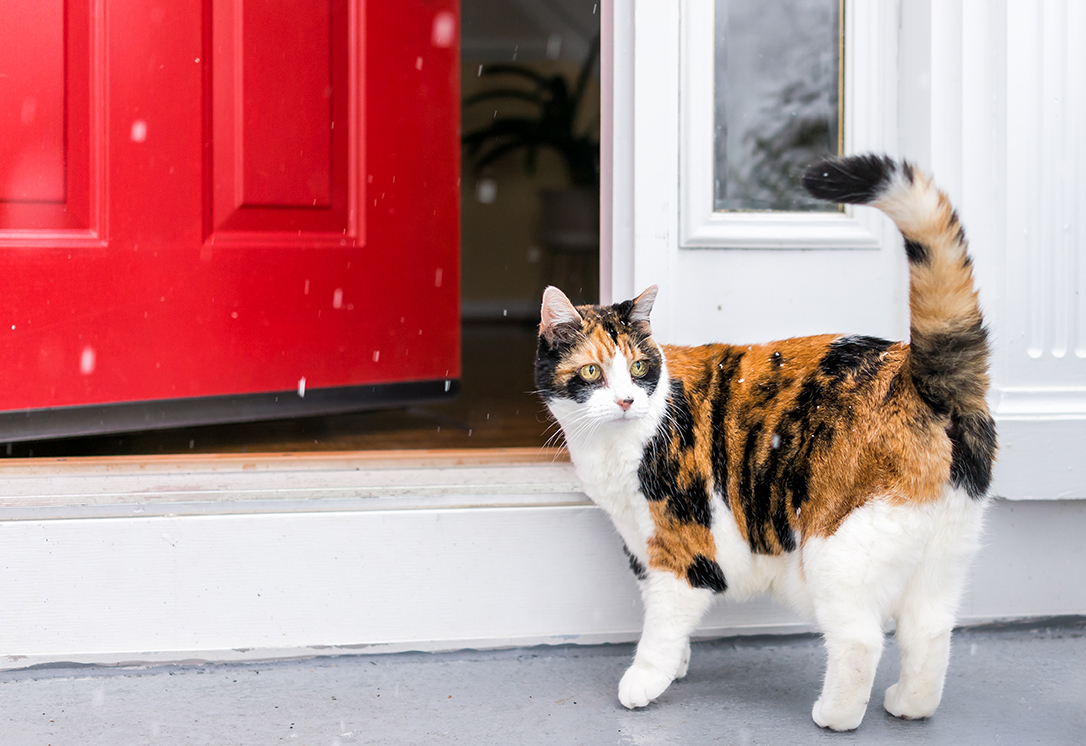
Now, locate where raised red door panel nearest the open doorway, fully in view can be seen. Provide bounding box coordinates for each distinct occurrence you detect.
[205,0,364,245]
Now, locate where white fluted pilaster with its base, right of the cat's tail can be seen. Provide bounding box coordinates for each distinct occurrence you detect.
[977,0,1086,500]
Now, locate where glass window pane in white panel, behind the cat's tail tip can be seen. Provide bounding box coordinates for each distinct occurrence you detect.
[714,0,843,211]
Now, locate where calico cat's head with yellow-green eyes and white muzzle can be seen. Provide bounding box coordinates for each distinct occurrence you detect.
[535,286,662,421]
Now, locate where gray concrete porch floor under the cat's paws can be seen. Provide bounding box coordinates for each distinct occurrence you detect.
[0,618,1086,746]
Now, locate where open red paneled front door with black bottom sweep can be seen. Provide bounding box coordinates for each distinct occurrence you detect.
[0,0,459,441]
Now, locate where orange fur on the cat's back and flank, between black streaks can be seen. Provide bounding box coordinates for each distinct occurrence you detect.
[657,334,951,545]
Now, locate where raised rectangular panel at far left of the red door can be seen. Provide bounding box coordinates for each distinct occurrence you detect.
[0,0,105,248]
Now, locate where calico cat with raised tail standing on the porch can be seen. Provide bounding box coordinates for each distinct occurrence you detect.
[535,155,996,731]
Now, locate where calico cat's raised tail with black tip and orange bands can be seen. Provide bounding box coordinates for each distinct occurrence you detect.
[804,155,996,497]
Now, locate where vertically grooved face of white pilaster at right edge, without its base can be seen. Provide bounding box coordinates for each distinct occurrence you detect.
[1001,0,1086,390]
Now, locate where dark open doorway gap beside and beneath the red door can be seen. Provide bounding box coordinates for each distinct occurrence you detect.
[0,0,599,457]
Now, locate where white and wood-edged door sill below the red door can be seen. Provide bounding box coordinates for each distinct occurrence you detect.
[0,448,589,520]
